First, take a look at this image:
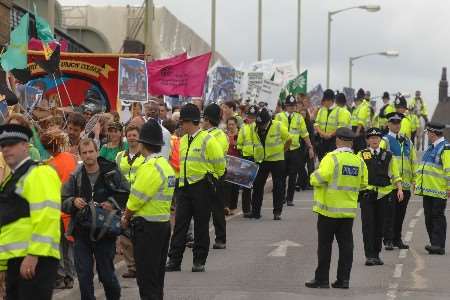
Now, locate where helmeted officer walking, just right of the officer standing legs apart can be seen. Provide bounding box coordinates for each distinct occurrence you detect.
[275,95,314,206]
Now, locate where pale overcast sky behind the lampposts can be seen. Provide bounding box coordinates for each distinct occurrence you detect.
[59,0,450,115]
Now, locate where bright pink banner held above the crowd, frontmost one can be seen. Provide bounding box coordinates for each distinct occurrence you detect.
[147,53,211,97]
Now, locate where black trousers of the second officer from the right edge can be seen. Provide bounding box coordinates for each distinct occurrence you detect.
[384,190,411,242]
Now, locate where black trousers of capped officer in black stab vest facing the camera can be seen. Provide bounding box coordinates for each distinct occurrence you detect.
[360,192,391,258]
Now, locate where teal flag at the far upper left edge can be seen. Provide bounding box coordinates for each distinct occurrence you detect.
[1,13,30,72]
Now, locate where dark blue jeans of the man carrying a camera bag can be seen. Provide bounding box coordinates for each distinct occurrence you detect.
[74,236,120,300]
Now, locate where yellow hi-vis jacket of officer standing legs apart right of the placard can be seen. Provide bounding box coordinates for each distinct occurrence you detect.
[253,121,290,162]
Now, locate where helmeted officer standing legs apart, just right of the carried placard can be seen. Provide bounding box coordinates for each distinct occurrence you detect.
[252,108,291,221]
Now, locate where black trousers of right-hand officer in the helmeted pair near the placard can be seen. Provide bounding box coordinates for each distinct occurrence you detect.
[210,179,227,243]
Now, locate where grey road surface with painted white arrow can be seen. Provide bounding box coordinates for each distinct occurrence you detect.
[54,191,450,300]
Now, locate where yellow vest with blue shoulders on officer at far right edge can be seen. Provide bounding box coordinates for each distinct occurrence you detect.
[416,140,450,199]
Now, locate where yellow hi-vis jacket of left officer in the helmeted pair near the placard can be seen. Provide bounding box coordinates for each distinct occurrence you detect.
[179,130,226,187]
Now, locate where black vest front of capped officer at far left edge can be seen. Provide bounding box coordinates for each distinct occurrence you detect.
[0,159,37,227]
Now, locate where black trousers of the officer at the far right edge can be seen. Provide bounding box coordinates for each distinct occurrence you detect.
[423,196,447,249]
